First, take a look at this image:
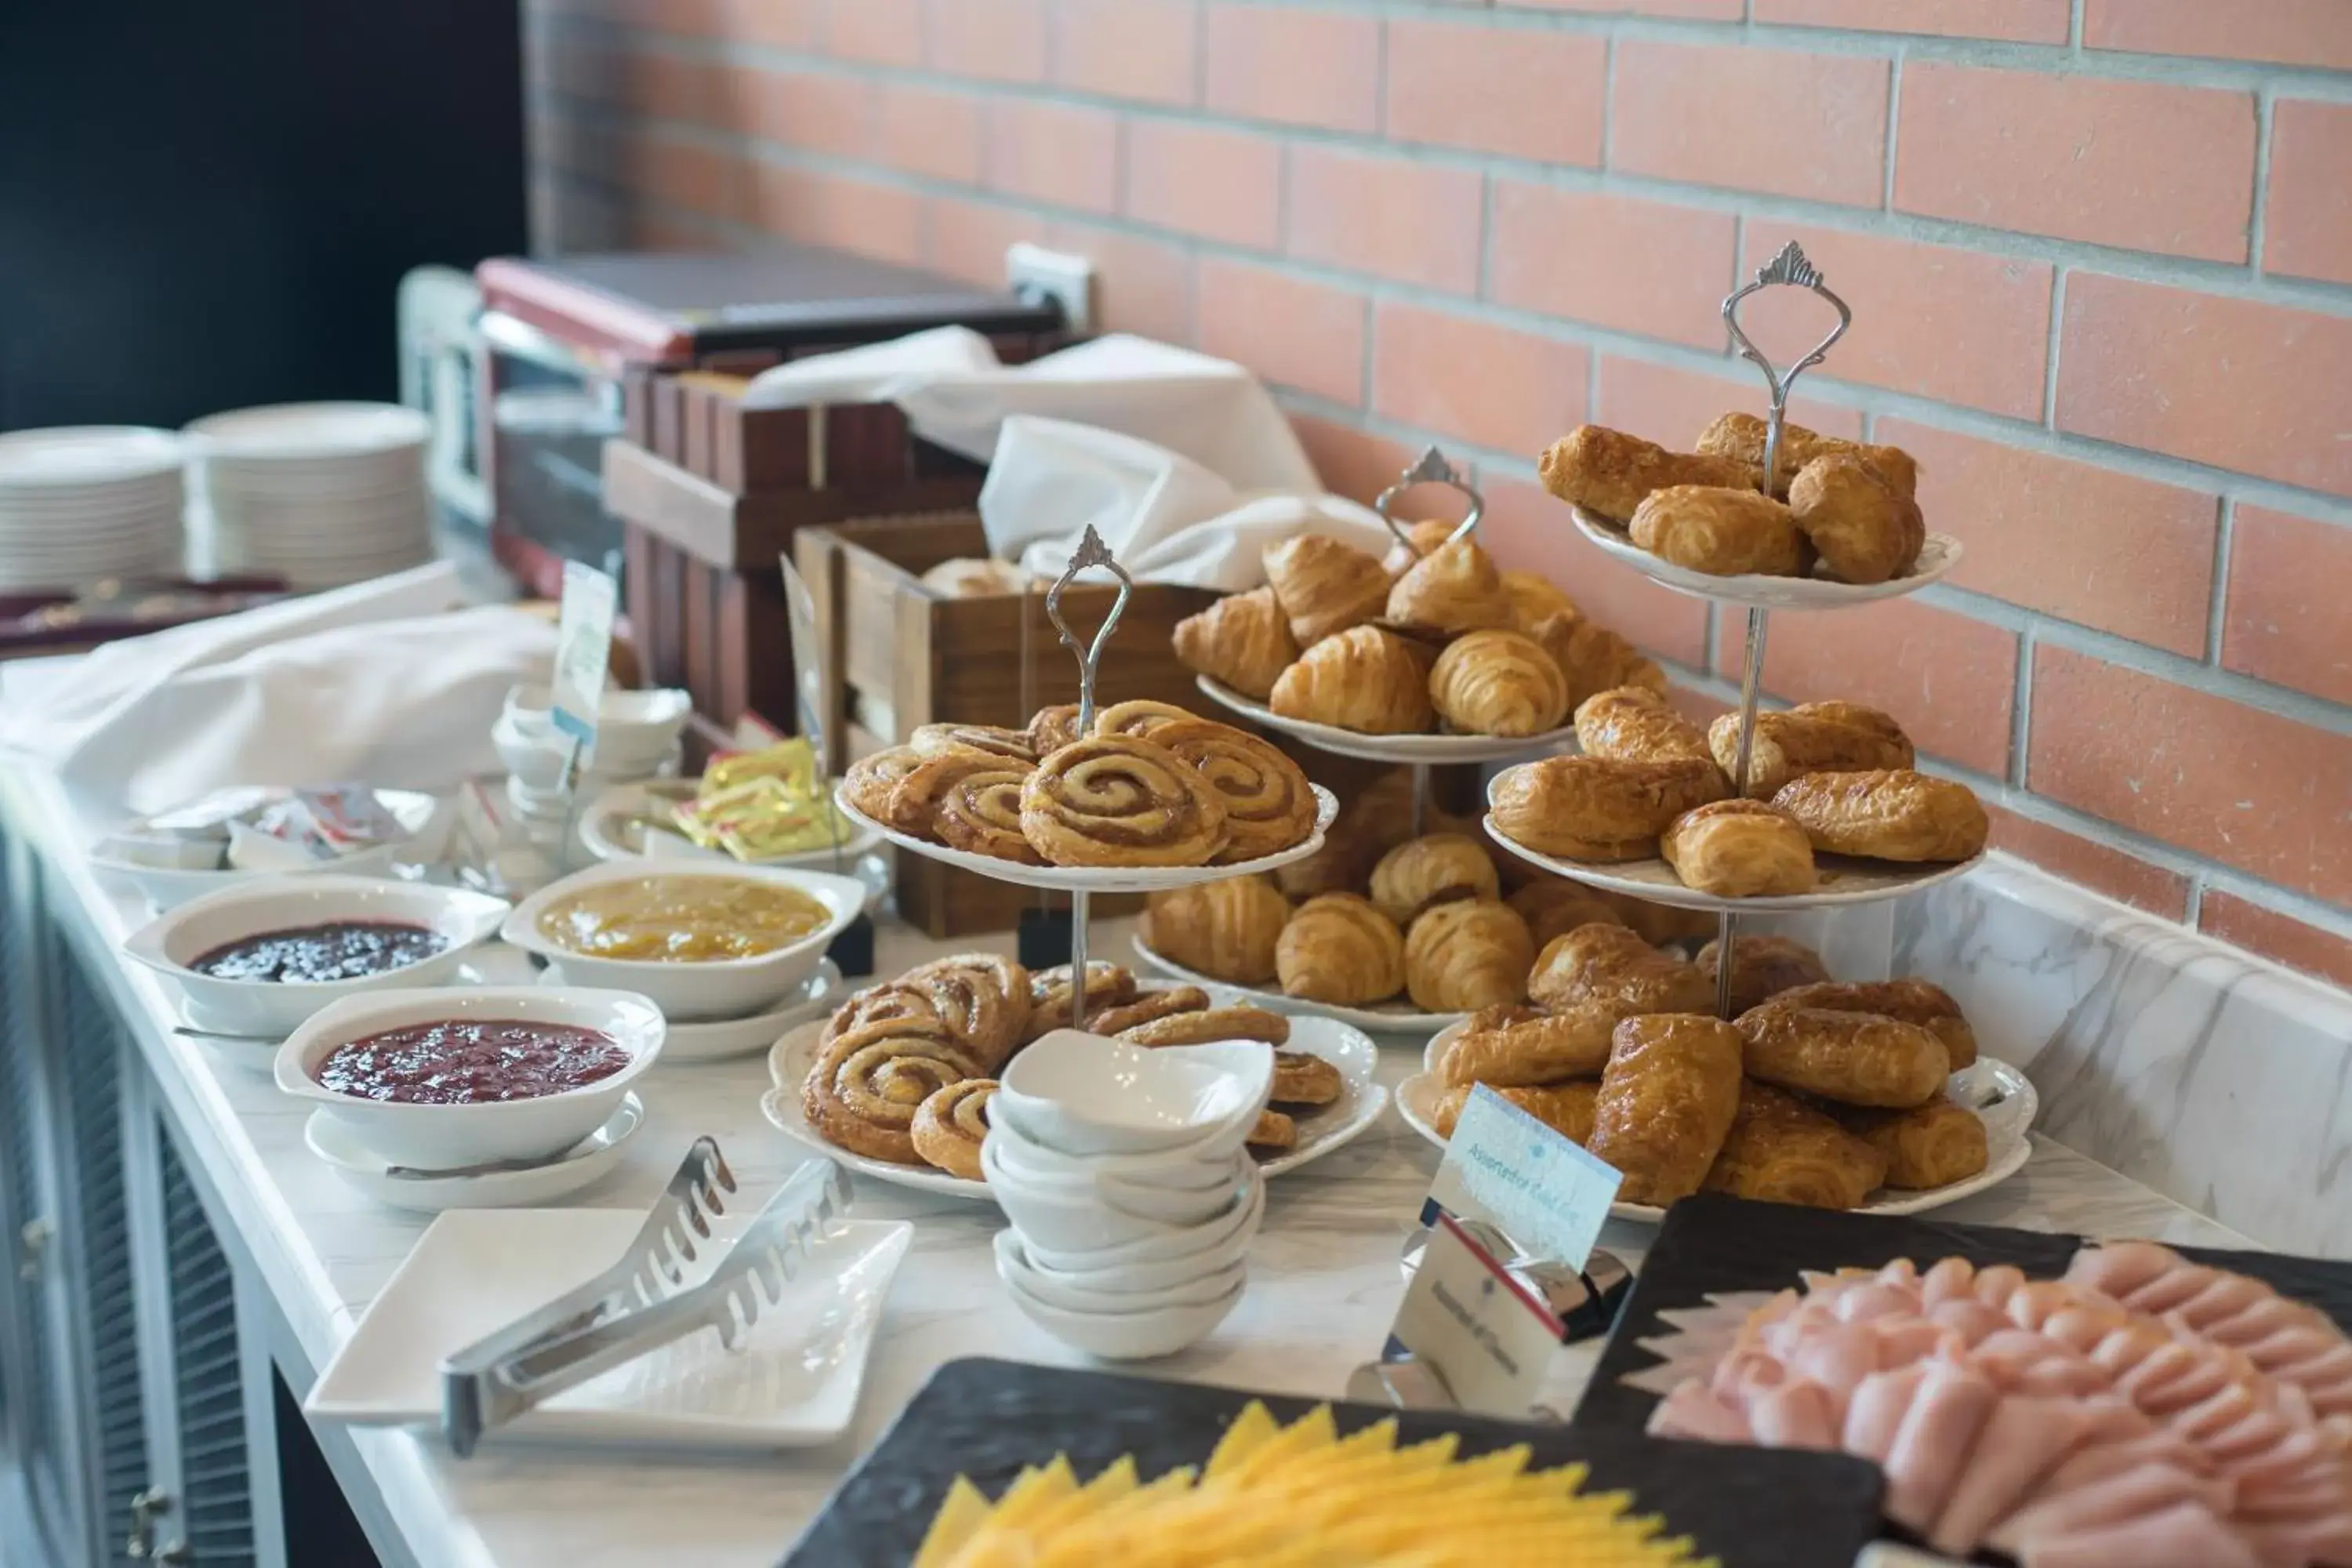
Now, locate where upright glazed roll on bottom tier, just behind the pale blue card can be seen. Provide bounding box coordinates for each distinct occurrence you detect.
[1585,1013,1740,1203]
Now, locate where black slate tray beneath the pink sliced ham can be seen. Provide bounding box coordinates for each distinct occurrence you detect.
[1571,1192,2352,1434]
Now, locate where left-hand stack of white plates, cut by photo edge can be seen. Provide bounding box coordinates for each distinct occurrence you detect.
[0,426,183,590]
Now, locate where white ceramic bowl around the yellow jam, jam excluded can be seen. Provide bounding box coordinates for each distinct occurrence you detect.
[501,860,866,1018]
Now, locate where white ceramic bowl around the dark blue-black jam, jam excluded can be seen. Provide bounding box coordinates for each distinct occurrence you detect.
[122,874,513,1039]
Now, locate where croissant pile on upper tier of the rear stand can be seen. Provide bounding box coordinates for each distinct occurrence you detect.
[1174,522,1665,736]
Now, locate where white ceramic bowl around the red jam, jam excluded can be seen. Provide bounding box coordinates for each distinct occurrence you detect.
[278,985,663,1171]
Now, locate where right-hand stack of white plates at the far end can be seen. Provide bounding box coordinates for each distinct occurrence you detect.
[188,402,433,588]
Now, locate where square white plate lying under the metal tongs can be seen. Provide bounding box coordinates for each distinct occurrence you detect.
[303,1203,915,1448]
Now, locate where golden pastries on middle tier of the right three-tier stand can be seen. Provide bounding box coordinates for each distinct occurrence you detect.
[1491,687,1992,898]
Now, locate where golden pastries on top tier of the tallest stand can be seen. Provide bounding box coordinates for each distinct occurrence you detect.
[1538,414,1926,583]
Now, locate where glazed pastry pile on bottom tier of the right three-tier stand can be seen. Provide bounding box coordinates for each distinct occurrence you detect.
[1435,924,1987,1208]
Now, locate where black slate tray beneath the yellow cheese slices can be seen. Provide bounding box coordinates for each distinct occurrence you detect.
[783,1359,1882,1568]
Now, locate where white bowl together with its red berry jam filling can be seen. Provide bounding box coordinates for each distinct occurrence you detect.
[278,985,663,1171]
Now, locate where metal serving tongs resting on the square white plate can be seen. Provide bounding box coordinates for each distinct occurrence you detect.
[440,1138,849,1457]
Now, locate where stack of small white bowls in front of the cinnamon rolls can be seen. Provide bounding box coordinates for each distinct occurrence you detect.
[981,1029,1275,1361]
